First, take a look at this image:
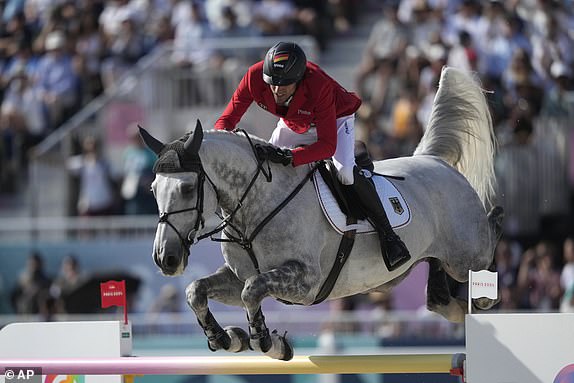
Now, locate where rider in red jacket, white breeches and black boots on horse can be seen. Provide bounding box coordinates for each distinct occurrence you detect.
[215,42,410,270]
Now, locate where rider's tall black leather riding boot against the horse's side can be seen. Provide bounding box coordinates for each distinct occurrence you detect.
[353,167,411,271]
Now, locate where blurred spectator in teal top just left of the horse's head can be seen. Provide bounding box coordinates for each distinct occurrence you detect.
[121,124,157,214]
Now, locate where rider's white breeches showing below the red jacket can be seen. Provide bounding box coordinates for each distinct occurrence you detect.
[269,114,355,185]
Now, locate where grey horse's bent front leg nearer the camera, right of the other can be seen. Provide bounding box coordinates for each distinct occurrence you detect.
[241,261,309,360]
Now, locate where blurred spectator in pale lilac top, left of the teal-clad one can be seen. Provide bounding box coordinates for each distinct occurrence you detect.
[67,136,116,216]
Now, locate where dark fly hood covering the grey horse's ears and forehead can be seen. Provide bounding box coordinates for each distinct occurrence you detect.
[140,120,203,173]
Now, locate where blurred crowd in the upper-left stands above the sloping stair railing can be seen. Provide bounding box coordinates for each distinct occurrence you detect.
[0,0,357,192]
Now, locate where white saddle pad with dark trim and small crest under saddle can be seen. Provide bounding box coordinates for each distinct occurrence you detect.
[313,172,411,234]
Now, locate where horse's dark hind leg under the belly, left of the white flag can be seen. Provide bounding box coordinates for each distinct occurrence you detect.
[427,258,467,323]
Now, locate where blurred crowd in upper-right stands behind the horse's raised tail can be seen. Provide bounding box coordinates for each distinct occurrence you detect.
[356,0,574,158]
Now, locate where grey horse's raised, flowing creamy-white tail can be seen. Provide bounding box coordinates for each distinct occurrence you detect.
[414,67,496,211]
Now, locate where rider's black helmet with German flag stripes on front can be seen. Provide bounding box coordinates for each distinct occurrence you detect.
[263,42,307,86]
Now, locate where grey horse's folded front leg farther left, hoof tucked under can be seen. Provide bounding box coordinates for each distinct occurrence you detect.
[185,265,249,352]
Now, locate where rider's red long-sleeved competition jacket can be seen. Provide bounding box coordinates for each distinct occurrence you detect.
[215,61,361,166]
